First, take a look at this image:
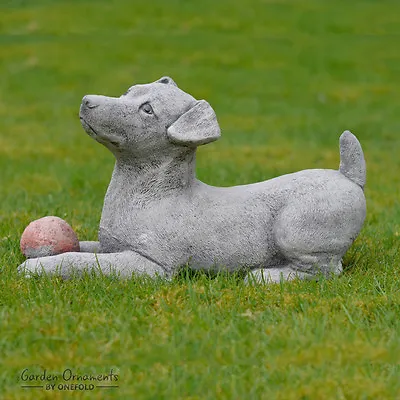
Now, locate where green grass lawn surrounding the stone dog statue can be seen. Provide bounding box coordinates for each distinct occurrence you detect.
[0,0,400,400]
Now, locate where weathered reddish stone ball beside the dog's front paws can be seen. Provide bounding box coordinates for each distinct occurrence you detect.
[20,216,79,258]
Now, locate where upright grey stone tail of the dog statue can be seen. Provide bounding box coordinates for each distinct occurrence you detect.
[339,131,366,188]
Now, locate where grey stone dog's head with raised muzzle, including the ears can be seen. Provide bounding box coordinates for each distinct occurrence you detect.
[79,77,221,158]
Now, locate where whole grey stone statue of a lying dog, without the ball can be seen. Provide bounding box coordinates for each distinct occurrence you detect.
[19,77,366,282]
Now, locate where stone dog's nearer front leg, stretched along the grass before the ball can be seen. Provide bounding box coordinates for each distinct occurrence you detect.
[18,251,169,278]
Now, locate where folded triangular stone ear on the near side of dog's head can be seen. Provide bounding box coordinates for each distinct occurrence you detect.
[167,100,221,147]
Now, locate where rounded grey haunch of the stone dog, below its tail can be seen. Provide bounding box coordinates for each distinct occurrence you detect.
[274,191,365,277]
